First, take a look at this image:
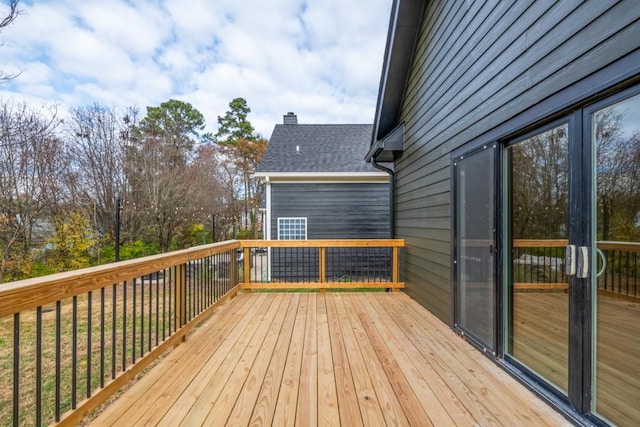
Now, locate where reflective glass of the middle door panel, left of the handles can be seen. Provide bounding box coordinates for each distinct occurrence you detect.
[505,124,569,394]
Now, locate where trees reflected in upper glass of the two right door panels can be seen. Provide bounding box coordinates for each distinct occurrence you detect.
[509,106,640,242]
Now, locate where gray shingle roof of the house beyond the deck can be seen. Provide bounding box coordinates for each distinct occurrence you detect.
[258,124,377,172]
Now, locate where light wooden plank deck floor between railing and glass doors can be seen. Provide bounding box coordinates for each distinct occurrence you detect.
[92,293,569,426]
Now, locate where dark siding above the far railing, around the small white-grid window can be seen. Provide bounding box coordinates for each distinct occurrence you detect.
[271,183,389,239]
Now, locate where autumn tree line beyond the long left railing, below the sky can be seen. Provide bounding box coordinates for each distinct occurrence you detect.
[0,98,267,283]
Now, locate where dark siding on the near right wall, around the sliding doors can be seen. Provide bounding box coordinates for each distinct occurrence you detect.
[395,0,640,323]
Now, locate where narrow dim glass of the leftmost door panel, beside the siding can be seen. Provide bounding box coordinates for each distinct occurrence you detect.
[454,145,496,352]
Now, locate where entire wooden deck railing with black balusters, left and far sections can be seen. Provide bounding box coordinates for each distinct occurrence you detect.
[0,240,404,426]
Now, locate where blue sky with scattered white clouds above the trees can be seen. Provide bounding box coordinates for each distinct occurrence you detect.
[0,0,391,137]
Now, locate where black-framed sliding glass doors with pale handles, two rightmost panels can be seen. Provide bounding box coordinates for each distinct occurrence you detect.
[501,88,640,426]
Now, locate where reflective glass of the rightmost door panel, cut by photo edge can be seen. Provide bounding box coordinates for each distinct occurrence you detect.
[590,95,640,426]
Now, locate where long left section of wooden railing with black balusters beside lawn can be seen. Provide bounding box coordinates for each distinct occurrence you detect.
[0,241,240,426]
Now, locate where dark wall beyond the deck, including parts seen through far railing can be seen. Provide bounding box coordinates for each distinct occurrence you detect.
[271,183,391,281]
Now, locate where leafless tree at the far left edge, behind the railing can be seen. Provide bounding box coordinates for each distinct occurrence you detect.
[0,103,68,283]
